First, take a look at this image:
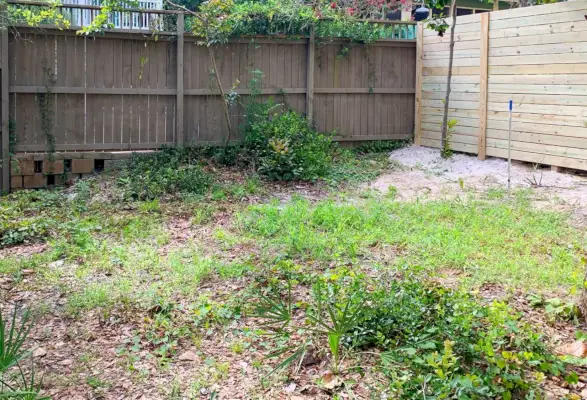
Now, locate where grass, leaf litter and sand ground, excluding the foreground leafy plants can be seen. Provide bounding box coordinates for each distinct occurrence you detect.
[0,148,587,400]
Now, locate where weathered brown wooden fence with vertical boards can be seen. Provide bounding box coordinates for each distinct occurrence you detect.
[1,2,416,191]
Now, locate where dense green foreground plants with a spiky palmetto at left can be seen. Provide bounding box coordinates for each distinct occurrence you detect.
[256,269,577,399]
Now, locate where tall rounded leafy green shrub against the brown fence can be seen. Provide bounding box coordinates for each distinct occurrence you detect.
[245,111,332,181]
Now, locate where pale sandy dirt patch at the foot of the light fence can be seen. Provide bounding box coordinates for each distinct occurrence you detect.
[370,146,587,226]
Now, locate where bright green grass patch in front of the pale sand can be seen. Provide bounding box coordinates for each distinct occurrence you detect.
[240,198,585,289]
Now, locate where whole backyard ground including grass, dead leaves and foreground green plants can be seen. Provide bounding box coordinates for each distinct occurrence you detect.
[0,148,587,400]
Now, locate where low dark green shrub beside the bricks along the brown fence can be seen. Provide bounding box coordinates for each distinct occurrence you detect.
[119,149,212,200]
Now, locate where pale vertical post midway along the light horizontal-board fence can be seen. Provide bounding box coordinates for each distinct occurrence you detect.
[477,13,491,160]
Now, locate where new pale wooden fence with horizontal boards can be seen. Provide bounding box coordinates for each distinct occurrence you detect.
[415,0,587,170]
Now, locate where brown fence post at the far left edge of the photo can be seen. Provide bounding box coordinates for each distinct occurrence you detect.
[1,23,10,193]
